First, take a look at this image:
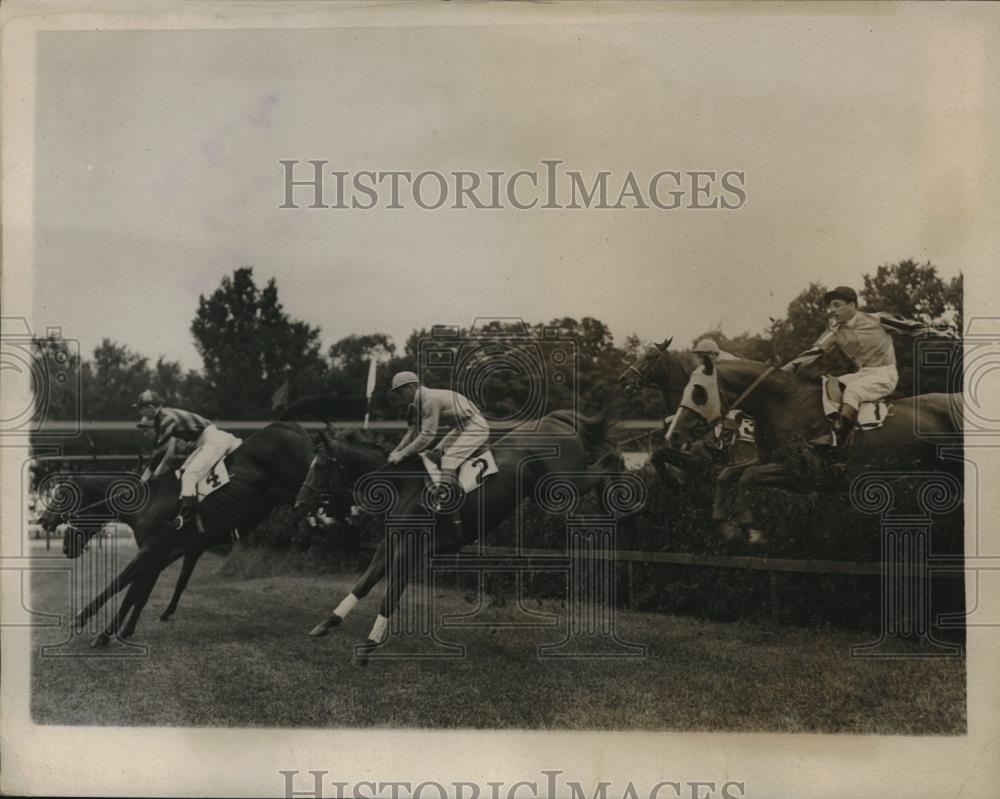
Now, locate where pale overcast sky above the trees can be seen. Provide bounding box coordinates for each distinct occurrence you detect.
[31,4,1000,368]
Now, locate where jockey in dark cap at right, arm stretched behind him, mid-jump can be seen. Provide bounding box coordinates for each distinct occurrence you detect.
[782,286,957,446]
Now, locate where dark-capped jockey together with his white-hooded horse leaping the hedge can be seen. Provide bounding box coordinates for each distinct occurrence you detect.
[622,287,962,540]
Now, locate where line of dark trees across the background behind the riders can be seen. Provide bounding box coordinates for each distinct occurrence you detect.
[35,259,963,421]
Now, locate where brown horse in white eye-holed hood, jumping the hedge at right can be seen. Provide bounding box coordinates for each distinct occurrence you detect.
[659,352,963,543]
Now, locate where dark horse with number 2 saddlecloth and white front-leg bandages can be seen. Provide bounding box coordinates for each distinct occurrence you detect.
[296,411,623,662]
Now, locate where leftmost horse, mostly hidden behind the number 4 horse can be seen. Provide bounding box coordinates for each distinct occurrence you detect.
[38,472,204,621]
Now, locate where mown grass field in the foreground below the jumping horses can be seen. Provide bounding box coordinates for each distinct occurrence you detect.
[31,540,966,734]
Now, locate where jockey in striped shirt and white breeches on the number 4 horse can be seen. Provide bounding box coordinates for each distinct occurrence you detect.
[134,389,240,529]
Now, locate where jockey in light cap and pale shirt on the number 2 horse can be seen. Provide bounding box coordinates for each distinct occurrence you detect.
[389,372,490,533]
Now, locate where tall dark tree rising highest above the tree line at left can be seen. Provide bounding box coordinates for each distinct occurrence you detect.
[191,266,328,419]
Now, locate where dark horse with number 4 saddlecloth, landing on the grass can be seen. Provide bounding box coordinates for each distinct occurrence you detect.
[69,421,312,645]
